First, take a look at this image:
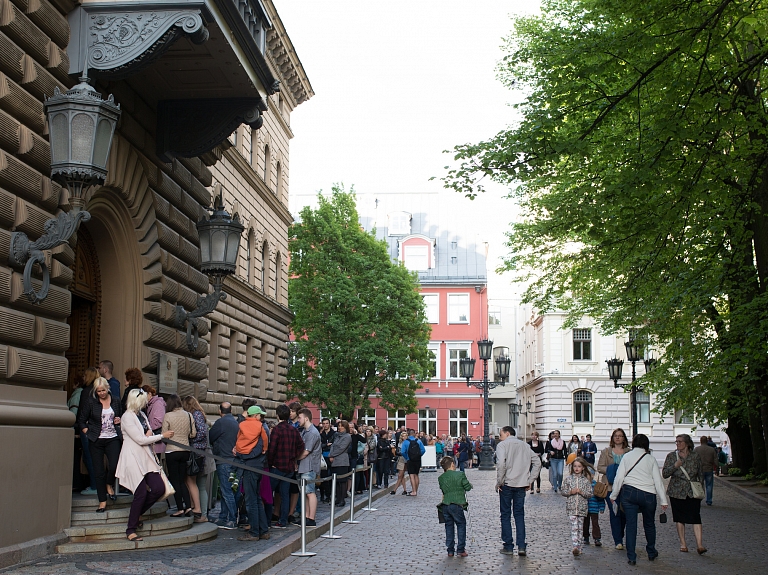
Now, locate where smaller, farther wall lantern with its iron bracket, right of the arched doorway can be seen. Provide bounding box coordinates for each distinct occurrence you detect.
[176,189,245,353]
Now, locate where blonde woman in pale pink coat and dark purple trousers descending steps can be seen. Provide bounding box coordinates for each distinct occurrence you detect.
[116,388,173,541]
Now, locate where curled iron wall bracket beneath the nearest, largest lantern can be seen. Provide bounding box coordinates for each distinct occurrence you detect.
[8,210,91,303]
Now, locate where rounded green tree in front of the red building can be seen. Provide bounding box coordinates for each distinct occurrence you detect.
[288,187,430,417]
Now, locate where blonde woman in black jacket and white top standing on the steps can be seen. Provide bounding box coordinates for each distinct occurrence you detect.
[77,378,122,513]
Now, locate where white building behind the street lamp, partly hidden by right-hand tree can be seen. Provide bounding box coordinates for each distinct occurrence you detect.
[517,306,727,461]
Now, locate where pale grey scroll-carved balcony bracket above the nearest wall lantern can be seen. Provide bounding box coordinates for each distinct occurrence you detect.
[67,2,208,80]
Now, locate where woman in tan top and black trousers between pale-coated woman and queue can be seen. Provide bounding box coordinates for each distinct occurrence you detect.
[163,393,197,517]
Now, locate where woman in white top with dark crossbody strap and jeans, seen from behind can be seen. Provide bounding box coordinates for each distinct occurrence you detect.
[611,433,667,565]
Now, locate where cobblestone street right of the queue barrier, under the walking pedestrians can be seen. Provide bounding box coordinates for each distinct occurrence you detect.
[266,470,768,575]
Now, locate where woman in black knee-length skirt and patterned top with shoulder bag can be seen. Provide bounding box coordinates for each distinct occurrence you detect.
[662,433,707,555]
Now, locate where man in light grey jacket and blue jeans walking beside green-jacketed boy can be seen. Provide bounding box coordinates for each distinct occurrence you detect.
[496,425,541,557]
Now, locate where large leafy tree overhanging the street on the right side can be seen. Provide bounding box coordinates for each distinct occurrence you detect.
[445,0,768,471]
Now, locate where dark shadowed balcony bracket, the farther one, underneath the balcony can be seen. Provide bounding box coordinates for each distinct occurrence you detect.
[157,98,267,162]
